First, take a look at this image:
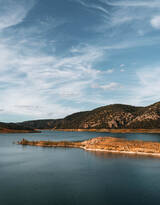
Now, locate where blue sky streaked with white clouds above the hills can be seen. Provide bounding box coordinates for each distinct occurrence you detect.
[0,0,160,122]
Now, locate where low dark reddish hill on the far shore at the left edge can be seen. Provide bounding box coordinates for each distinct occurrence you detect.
[0,122,36,133]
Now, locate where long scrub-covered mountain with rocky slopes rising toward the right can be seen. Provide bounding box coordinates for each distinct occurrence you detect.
[19,102,160,129]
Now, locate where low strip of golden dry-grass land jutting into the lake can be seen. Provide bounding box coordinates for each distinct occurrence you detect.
[17,137,160,157]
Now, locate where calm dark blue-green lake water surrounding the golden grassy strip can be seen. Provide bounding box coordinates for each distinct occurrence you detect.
[0,131,160,205]
